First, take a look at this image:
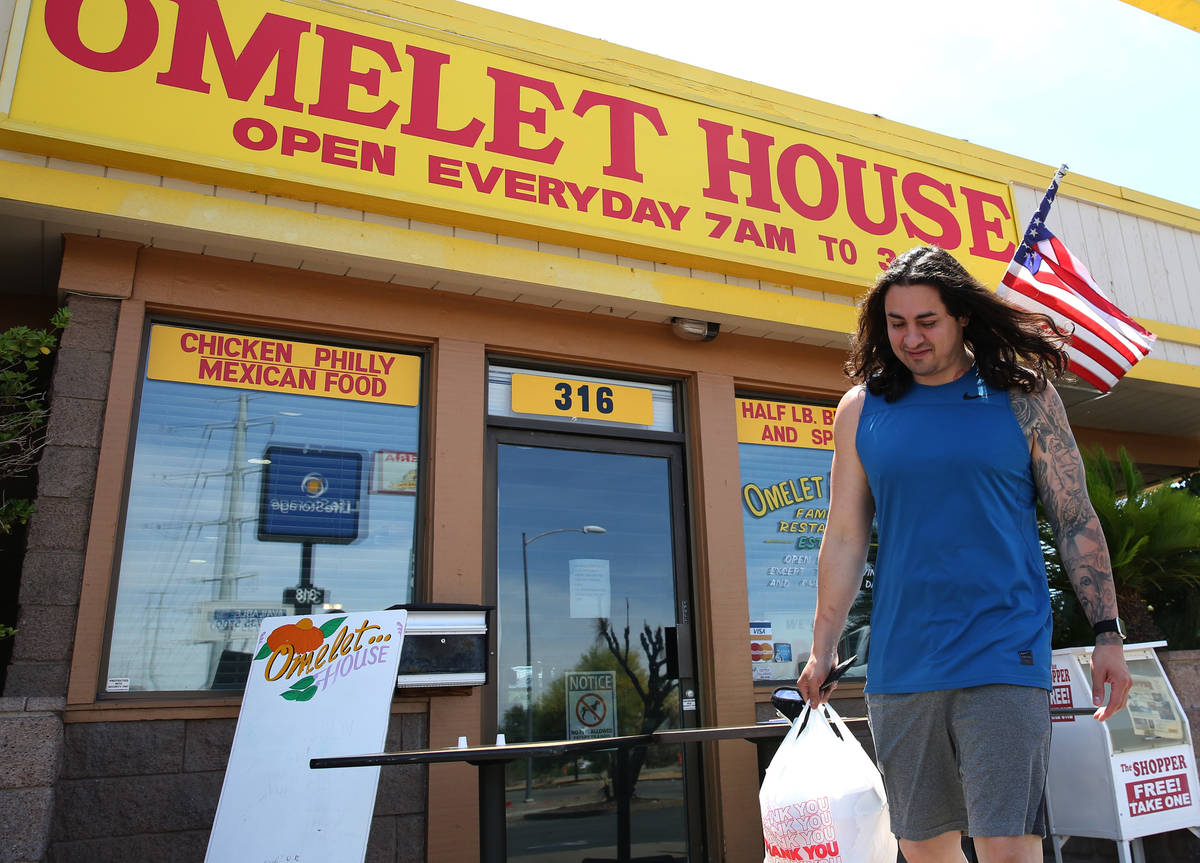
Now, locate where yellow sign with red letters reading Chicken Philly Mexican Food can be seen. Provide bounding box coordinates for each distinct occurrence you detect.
[146,324,421,404]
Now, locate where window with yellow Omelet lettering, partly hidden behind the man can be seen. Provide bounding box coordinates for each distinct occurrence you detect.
[734,398,870,685]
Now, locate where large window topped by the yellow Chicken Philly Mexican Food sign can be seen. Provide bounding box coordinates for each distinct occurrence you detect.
[102,324,421,693]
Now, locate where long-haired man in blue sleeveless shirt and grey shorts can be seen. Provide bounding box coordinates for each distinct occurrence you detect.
[799,246,1132,863]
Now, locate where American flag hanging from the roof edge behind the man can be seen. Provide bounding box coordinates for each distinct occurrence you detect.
[996,164,1154,392]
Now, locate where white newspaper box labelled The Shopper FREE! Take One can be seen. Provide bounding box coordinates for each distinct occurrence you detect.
[1046,641,1200,863]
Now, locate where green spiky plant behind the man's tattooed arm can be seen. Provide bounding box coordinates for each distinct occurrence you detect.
[1040,447,1200,648]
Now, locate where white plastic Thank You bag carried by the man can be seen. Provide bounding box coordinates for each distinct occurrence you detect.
[758,705,896,863]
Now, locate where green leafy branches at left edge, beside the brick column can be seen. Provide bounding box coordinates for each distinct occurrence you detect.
[0,308,71,639]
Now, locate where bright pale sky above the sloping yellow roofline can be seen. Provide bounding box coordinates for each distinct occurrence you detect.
[472,0,1200,208]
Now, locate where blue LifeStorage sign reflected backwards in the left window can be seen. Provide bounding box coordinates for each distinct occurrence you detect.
[258,447,362,543]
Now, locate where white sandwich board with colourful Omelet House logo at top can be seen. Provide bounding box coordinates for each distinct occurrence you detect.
[205,610,408,863]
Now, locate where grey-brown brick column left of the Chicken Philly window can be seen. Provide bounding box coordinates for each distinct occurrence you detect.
[0,295,119,863]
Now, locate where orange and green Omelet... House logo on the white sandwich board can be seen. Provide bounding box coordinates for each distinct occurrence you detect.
[254,614,403,701]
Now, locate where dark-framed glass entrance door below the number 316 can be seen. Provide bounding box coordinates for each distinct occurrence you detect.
[492,430,700,863]
